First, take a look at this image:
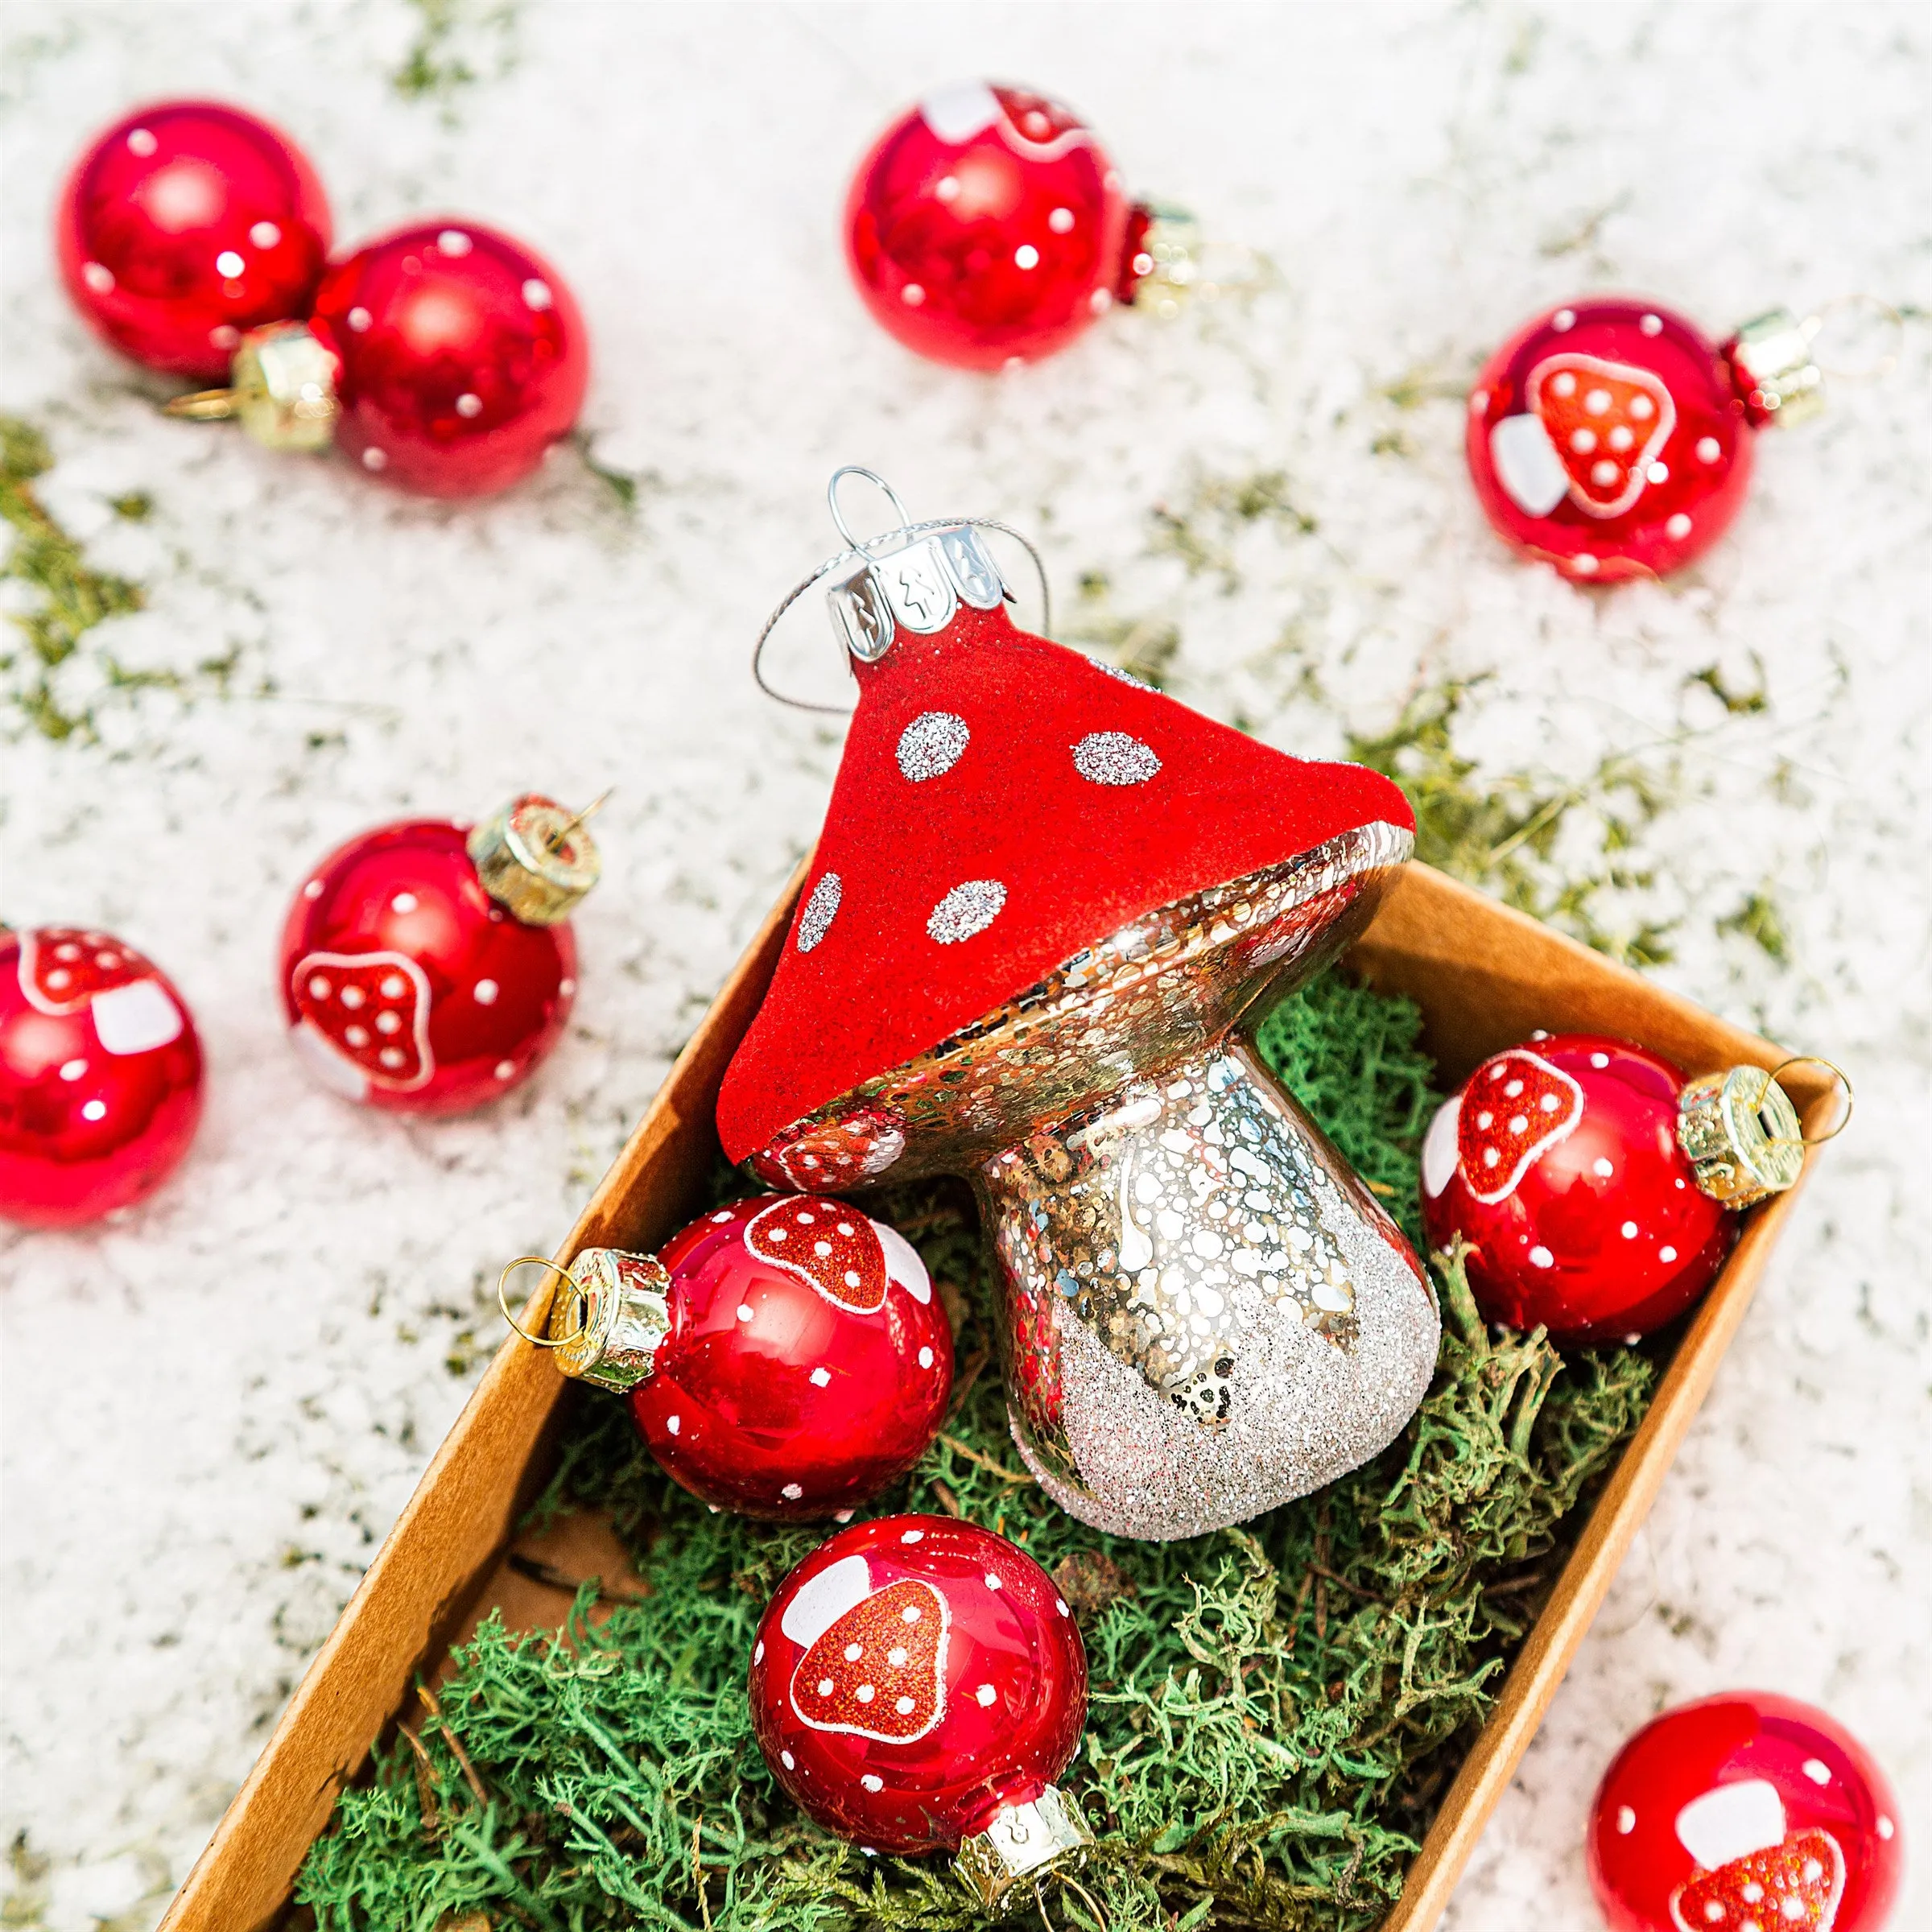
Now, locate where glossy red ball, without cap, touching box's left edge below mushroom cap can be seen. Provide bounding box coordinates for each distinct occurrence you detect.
[630,1194,952,1521]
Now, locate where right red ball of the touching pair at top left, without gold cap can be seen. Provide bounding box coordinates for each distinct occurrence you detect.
[309,218,591,497]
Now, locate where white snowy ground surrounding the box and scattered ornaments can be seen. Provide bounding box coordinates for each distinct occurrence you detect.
[0,11,1932,1932]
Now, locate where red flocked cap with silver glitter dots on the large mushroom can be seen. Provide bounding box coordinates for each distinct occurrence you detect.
[716,544,1414,1161]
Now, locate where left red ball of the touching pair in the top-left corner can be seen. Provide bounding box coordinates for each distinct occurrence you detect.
[54,101,330,382]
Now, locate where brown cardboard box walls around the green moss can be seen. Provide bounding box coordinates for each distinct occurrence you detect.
[163,864,1835,1932]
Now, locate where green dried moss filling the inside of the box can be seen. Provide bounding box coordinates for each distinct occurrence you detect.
[298,976,1652,1932]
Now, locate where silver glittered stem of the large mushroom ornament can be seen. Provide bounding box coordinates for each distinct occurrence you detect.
[974,1039,1439,1540]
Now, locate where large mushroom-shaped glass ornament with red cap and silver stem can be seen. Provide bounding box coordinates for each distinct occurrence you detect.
[716,479,1439,1538]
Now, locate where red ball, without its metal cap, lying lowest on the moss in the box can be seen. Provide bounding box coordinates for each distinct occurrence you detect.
[749,1517,1086,1853]
